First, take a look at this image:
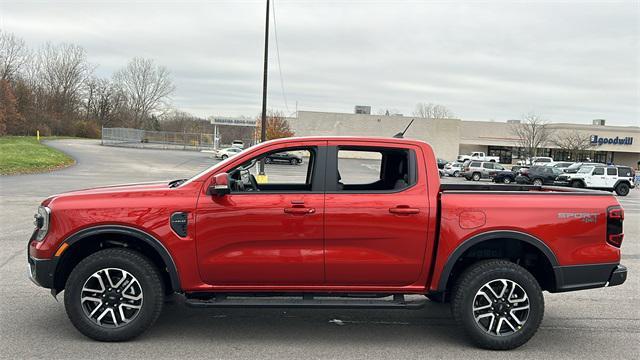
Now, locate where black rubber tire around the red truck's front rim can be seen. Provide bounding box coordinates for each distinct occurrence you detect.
[64,248,165,341]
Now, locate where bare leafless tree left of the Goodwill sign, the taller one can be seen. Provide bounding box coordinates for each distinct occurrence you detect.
[511,112,551,157]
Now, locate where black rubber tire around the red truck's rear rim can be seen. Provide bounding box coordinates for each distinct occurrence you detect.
[451,259,544,350]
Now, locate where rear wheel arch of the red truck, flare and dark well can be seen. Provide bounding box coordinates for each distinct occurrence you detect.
[437,230,559,294]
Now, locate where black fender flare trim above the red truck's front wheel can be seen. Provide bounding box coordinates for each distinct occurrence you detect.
[62,225,181,292]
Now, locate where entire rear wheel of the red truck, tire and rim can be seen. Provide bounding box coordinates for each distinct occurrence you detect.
[451,260,544,350]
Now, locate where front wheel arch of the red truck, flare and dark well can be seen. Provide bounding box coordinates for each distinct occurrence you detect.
[53,225,181,293]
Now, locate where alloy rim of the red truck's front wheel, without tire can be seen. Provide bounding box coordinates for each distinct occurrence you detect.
[80,268,143,328]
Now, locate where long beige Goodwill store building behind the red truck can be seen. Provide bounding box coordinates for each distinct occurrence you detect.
[287,111,640,167]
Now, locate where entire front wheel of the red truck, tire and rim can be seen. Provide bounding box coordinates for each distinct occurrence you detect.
[64,248,164,341]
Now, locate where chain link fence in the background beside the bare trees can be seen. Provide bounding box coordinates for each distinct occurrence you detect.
[102,128,215,151]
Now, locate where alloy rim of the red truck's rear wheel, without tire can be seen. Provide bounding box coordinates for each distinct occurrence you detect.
[472,279,530,336]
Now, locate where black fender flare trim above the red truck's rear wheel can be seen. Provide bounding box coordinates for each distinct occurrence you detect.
[437,230,558,292]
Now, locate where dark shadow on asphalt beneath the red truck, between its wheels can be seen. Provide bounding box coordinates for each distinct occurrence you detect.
[148,301,464,347]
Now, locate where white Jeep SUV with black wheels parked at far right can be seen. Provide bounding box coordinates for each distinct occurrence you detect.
[557,166,634,196]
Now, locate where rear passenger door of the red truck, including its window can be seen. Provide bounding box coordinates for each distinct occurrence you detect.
[325,141,437,286]
